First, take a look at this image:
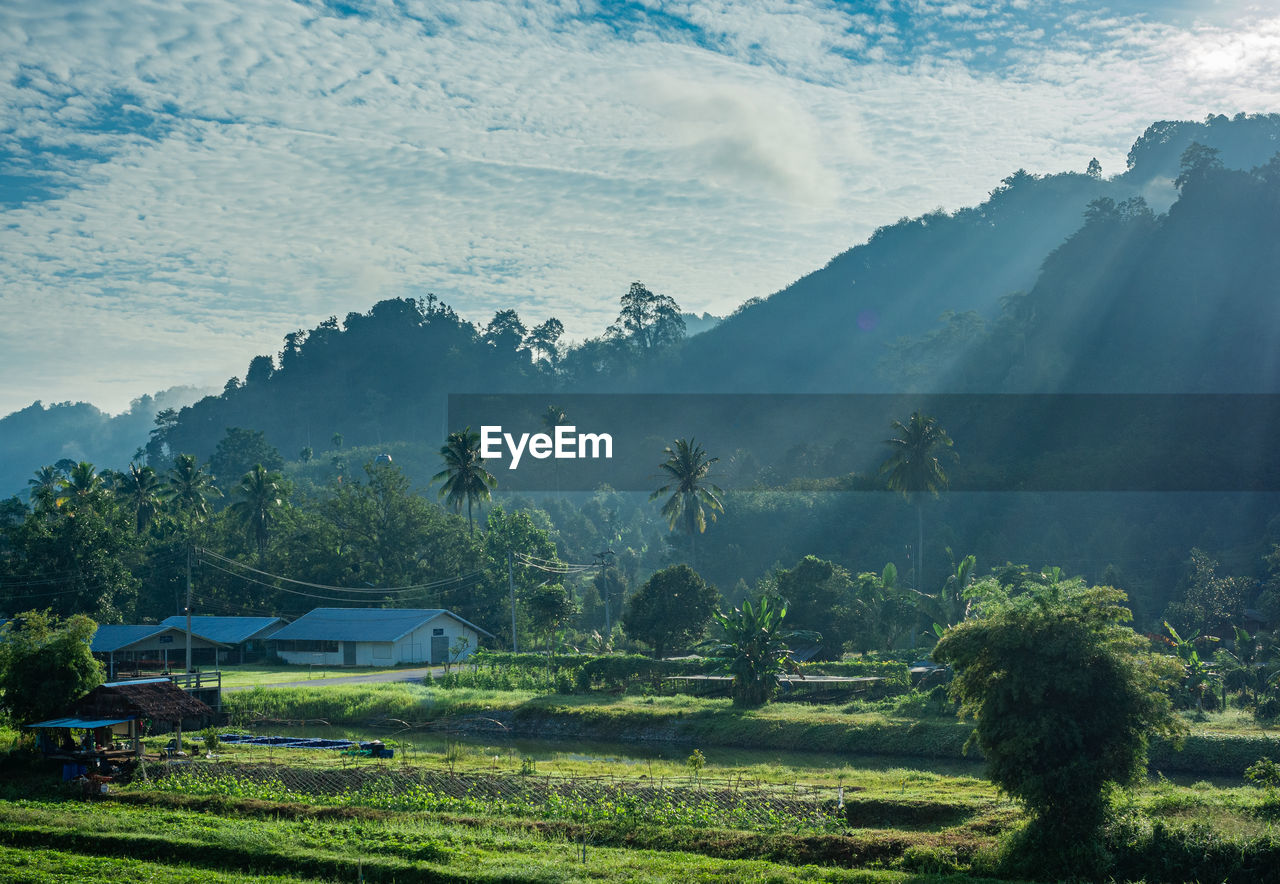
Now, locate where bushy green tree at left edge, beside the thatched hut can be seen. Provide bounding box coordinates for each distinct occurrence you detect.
[0,610,102,724]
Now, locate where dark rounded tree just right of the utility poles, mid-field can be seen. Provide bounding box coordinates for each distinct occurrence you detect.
[622,564,719,659]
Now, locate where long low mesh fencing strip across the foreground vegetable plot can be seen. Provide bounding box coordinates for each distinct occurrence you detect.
[142,764,844,832]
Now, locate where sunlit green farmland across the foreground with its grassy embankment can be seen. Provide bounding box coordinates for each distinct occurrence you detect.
[0,684,1280,884]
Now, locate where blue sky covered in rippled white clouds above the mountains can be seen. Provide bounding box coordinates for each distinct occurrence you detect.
[0,0,1280,414]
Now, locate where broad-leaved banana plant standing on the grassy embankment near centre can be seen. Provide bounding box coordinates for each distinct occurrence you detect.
[701,596,820,707]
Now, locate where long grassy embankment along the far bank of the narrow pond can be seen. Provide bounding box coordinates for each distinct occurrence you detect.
[224,684,1280,777]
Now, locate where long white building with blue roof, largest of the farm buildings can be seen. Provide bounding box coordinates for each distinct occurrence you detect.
[271,608,494,667]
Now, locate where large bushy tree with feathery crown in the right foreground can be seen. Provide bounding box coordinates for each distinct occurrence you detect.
[933,580,1181,880]
